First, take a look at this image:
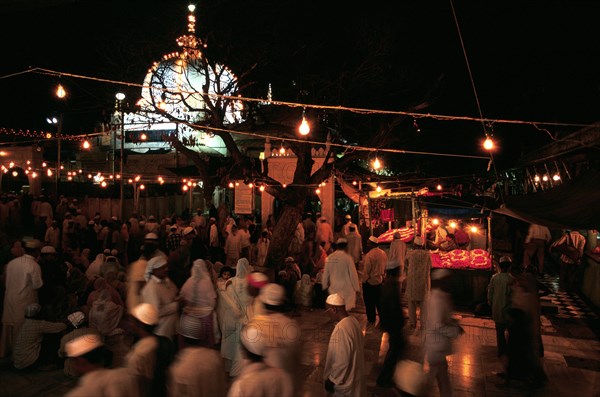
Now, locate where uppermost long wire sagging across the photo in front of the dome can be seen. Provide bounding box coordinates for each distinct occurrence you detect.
[0,67,593,129]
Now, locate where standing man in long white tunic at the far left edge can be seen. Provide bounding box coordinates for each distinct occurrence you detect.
[0,240,43,357]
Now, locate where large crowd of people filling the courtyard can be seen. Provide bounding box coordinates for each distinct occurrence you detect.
[0,193,584,396]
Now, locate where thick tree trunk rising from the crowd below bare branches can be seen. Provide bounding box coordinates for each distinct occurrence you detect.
[265,202,304,279]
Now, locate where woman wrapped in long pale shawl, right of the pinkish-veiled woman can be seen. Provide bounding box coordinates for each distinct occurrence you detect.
[217,258,252,377]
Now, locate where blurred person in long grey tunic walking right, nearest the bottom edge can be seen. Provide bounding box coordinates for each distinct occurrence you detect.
[424,269,464,397]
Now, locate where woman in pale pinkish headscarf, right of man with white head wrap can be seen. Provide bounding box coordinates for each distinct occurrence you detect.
[179,259,217,347]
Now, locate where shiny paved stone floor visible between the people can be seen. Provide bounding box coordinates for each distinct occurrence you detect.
[0,290,600,397]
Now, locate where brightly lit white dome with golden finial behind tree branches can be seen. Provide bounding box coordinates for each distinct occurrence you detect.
[125,6,242,155]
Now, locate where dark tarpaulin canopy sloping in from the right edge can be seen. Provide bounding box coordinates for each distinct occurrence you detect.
[494,171,600,230]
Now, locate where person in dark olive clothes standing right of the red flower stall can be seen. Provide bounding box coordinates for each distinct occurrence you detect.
[487,256,514,357]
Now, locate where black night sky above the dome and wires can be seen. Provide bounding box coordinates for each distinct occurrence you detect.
[0,0,600,173]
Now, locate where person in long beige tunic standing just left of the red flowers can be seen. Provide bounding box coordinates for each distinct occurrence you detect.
[406,236,431,328]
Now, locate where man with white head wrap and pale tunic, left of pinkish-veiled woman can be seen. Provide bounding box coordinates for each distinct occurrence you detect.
[140,256,179,340]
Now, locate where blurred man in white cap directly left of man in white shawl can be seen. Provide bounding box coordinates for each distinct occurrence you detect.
[250,283,302,395]
